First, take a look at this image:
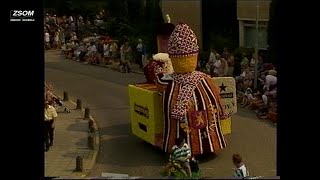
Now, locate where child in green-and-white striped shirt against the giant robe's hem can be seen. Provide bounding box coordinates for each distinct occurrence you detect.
[171,137,192,177]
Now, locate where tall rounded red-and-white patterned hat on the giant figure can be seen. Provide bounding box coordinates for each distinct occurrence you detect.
[168,23,199,57]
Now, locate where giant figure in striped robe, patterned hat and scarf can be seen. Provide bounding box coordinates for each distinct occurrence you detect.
[156,23,227,156]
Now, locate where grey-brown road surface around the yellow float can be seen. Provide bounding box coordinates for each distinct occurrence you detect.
[45,52,276,178]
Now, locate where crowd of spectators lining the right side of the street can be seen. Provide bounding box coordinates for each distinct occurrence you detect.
[206,49,277,122]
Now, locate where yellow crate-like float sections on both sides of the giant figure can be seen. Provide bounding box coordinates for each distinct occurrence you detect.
[129,71,237,148]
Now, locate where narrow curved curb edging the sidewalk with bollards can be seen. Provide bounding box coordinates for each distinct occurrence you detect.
[69,99,100,178]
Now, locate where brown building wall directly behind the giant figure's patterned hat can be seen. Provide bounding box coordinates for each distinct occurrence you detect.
[160,0,202,48]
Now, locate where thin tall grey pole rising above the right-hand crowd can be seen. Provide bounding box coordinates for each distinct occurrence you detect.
[253,0,260,89]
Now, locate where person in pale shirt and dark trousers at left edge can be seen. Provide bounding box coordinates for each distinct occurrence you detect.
[44,101,58,151]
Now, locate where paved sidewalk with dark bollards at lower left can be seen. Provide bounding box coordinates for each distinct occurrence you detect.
[45,102,99,179]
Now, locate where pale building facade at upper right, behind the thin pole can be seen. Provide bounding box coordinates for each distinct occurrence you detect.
[237,0,271,50]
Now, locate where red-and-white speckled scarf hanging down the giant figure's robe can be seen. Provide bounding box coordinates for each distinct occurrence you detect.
[171,71,207,121]
